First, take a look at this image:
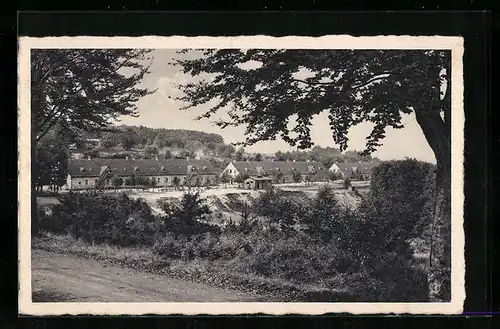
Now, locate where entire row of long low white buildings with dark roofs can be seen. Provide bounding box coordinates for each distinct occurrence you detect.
[66,158,375,190]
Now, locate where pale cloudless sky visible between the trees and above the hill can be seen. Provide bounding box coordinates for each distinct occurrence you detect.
[119,49,436,163]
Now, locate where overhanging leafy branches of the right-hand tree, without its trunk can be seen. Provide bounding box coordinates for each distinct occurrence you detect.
[175,49,449,152]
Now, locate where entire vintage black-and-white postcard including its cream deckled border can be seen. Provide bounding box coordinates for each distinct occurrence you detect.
[19,35,465,315]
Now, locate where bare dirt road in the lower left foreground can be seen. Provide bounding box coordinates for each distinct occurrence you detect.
[32,250,262,302]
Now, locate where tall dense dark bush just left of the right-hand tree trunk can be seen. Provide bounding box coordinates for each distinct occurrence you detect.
[359,159,435,255]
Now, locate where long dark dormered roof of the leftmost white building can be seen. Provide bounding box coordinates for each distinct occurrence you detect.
[68,159,215,177]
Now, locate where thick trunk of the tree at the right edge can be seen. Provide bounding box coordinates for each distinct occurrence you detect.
[415,110,451,302]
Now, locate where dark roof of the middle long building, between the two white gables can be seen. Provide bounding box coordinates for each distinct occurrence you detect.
[232,161,326,175]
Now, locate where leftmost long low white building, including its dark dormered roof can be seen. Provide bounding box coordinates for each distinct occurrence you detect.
[66,159,217,190]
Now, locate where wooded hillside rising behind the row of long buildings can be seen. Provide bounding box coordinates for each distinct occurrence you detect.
[76,125,376,168]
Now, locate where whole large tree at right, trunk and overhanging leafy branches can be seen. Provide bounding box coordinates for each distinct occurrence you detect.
[174,49,451,301]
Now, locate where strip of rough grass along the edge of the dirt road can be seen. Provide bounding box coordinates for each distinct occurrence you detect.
[33,232,355,301]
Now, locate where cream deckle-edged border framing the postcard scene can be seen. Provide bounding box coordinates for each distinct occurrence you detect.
[18,35,465,315]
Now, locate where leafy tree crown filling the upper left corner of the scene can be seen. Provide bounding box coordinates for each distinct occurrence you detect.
[31,49,150,141]
